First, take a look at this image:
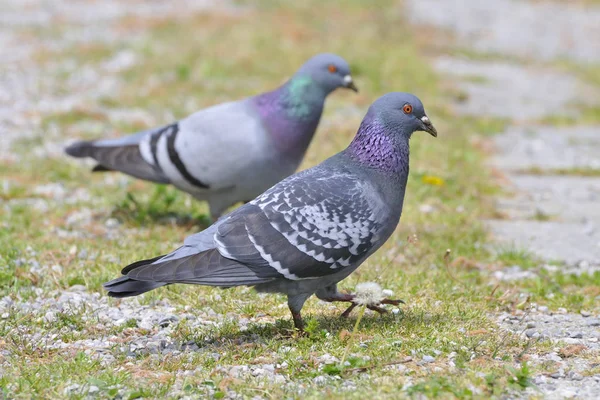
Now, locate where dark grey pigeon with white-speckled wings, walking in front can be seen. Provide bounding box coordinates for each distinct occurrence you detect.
[104,93,437,330]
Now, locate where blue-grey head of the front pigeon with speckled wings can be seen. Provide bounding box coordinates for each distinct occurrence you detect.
[367,92,437,138]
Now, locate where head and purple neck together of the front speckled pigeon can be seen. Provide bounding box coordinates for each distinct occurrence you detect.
[347,92,437,175]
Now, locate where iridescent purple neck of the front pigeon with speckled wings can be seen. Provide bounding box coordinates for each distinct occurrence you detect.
[346,115,409,180]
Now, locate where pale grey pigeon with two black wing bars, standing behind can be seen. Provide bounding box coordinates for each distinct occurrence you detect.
[65,53,358,221]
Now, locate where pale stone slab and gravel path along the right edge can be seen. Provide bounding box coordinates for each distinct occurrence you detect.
[405,0,600,399]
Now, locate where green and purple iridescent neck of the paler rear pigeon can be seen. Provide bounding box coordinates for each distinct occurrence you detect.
[255,75,327,156]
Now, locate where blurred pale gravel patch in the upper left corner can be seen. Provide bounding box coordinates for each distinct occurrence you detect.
[0,0,241,162]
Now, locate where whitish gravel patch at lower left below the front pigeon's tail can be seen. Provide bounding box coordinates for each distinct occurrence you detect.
[0,285,248,363]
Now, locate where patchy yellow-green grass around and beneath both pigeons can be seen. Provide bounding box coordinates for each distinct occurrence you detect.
[0,0,600,399]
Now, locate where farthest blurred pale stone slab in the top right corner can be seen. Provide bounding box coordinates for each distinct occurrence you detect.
[406,0,600,63]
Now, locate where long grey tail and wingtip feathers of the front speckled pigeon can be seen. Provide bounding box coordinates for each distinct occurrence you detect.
[104,249,276,297]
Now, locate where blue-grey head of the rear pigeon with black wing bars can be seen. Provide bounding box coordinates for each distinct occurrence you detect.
[295,53,358,93]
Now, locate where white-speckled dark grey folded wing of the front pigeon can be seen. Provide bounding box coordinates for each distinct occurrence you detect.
[214,170,381,280]
